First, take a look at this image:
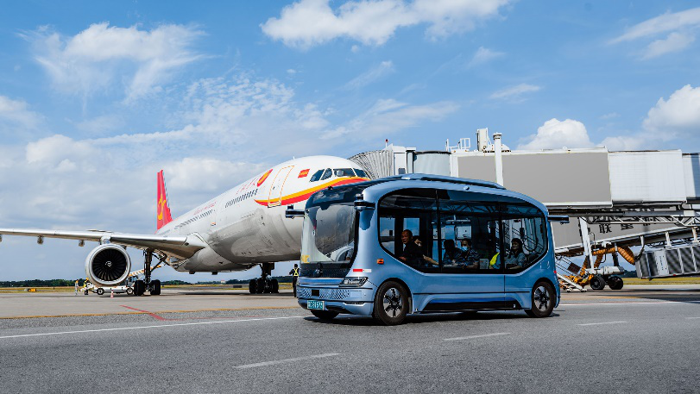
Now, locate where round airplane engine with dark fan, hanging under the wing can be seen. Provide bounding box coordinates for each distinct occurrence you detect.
[85,244,131,286]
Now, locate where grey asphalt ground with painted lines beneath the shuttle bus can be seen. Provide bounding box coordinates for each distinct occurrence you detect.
[0,286,700,393]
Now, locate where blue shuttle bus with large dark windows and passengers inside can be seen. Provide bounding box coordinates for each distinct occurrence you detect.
[296,174,560,325]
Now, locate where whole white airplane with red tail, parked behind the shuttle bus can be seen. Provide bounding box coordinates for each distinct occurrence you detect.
[0,156,369,295]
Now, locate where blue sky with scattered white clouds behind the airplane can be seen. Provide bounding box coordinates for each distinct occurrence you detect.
[0,0,700,280]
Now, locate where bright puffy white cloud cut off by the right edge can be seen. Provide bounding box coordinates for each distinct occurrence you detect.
[643,85,700,139]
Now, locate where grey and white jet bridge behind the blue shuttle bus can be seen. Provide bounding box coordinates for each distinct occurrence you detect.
[350,129,700,290]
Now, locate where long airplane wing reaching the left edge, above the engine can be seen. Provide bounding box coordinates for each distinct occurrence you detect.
[0,228,207,259]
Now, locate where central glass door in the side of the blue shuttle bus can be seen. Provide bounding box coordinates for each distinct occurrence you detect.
[433,191,505,309]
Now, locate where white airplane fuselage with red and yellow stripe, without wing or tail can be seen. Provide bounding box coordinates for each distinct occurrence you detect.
[156,156,367,272]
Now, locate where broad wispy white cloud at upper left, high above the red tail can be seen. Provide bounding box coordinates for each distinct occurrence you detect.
[24,22,203,101]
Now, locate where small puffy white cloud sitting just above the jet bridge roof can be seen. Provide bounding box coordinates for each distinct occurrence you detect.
[518,118,593,150]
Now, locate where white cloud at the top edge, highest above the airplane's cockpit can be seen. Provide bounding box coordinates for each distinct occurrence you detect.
[260,0,510,50]
